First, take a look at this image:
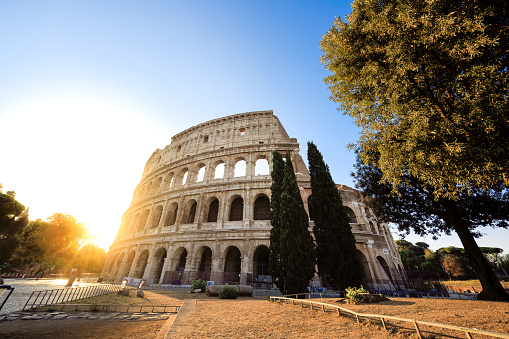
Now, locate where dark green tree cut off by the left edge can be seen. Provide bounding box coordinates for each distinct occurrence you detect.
[0,189,28,265]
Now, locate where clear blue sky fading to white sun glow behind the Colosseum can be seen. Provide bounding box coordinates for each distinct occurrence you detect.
[0,1,509,252]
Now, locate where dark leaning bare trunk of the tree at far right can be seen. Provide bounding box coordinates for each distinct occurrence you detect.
[446,201,509,301]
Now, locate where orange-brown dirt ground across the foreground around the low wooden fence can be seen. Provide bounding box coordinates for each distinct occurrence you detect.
[0,291,509,339]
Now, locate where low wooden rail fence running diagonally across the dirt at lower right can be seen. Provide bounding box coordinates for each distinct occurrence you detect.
[269,293,509,339]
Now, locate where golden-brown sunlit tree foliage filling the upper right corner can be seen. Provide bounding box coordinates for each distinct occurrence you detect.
[321,0,509,199]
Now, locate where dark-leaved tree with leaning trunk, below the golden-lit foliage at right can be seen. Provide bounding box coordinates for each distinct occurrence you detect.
[354,156,509,301]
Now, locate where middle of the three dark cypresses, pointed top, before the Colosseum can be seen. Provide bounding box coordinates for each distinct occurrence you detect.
[279,151,315,294]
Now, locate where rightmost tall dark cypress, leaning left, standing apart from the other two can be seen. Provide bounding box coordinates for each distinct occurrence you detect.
[308,142,362,290]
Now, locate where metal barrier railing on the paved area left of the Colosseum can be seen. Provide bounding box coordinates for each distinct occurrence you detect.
[23,284,123,310]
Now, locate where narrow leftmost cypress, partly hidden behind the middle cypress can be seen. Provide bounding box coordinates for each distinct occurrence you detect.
[269,151,285,291]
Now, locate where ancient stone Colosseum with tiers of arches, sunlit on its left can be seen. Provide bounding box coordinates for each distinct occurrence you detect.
[102,111,406,289]
